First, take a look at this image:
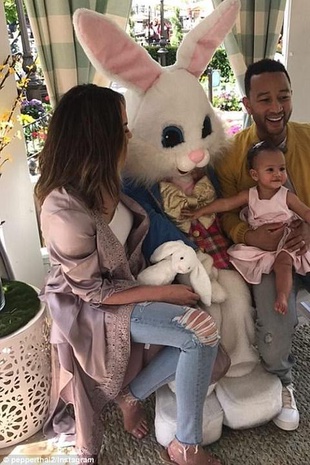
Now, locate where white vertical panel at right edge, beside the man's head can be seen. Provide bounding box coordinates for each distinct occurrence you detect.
[283,0,310,122]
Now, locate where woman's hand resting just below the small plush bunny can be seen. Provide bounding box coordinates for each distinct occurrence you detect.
[156,284,200,307]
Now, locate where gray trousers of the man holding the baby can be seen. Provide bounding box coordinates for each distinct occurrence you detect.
[252,272,310,386]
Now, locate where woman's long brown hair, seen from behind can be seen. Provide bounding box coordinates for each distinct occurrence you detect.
[35,84,126,211]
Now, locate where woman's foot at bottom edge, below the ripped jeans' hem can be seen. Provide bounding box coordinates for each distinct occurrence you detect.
[161,439,221,465]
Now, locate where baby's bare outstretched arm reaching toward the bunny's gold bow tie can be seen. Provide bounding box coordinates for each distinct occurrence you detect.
[181,190,249,219]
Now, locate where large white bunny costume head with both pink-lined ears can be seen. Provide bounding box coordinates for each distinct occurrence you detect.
[73,0,240,184]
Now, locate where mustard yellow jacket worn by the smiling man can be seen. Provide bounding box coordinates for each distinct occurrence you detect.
[215,122,310,243]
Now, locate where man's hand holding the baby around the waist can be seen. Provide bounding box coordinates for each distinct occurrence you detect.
[245,223,286,251]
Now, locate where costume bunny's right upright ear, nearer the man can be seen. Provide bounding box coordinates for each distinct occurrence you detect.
[175,0,240,78]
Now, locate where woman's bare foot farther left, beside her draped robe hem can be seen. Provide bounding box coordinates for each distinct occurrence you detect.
[115,388,149,439]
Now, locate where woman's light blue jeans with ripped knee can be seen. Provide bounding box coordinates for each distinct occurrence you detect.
[129,302,219,444]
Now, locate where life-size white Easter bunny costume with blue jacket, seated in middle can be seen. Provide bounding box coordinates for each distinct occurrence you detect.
[73,0,281,446]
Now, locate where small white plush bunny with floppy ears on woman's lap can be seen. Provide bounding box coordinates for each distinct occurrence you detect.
[137,241,211,306]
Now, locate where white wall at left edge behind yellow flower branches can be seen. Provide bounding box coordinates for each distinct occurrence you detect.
[0,2,44,288]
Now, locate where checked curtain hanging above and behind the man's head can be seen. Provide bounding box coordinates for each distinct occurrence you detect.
[212,0,286,125]
